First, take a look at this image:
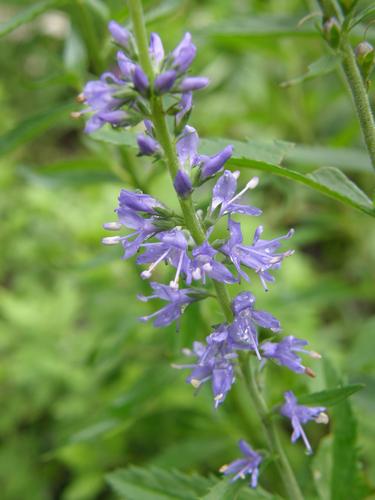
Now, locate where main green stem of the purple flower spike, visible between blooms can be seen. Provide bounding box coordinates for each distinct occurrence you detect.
[129,0,303,494]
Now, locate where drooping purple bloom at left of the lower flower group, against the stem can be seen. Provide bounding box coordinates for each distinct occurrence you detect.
[174,325,237,408]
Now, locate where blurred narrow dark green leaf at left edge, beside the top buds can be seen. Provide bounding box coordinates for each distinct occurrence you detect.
[0,102,77,155]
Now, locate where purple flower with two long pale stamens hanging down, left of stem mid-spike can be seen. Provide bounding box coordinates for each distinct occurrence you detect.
[137,229,190,289]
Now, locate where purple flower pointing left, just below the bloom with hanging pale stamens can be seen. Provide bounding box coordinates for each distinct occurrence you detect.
[138,282,197,327]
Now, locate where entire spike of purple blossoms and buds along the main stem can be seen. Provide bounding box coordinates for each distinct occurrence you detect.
[81,21,324,487]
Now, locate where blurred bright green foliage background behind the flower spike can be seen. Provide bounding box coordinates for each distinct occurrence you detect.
[0,0,375,500]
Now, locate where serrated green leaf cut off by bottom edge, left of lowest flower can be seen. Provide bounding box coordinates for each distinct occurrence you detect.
[107,467,214,500]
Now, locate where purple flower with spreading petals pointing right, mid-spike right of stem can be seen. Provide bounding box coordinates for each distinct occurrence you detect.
[220,219,294,290]
